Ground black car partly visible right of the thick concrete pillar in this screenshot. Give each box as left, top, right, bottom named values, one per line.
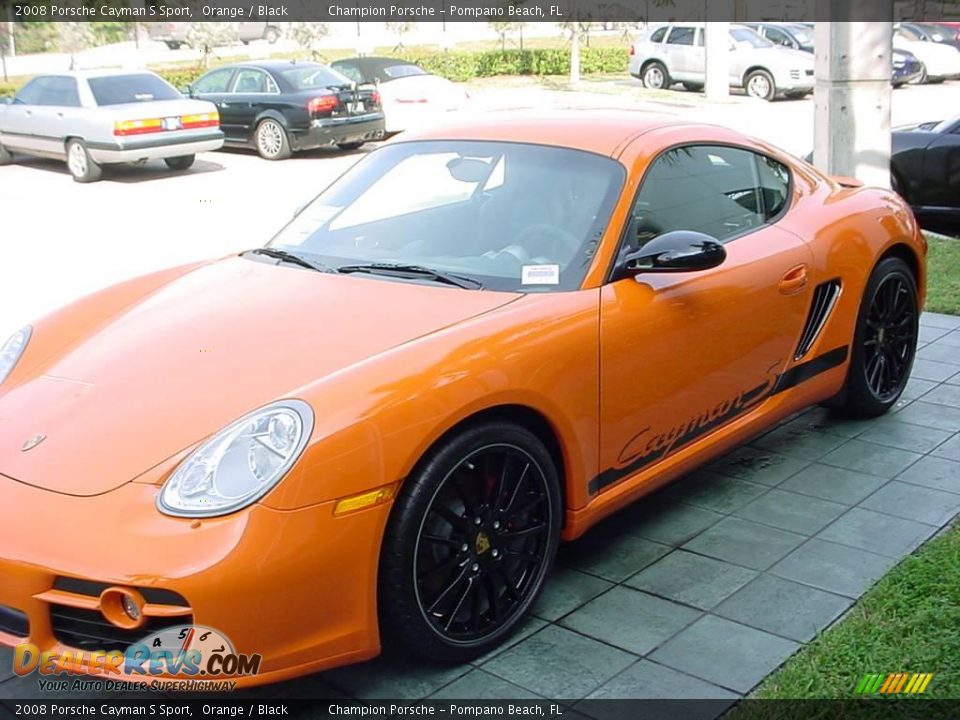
left=891, top=116, right=960, bottom=227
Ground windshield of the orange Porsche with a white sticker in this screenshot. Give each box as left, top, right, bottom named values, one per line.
left=270, top=140, right=626, bottom=292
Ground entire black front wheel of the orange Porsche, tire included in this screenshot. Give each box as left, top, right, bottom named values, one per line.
left=378, top=421, right=562, bottom=662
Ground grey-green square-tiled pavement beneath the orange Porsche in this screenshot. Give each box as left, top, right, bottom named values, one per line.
left=0, top=313, right=960, bottom=704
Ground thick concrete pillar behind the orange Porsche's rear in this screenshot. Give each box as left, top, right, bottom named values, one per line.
left=813, top=17, right=893, bottom=187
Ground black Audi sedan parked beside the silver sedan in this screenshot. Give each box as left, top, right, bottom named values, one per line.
left=185, top=60, right=384, bottom=160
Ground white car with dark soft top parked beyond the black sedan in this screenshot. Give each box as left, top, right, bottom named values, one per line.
left=330, top=57, right=470, bottom=133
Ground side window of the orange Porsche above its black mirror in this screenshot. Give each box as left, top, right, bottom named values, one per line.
left=628, top=145, right=790, bottom=248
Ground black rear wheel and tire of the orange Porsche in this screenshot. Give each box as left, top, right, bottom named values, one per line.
left=833, top=257, right=920, bottom=418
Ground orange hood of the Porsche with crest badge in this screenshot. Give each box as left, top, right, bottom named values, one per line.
left=0, top=257, right=520, bottom=495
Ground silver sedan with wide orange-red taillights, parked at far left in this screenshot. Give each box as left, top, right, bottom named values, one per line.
left=0, top=70, right=223, bottom=182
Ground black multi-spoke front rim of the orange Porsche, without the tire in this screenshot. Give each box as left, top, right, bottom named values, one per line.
left=414, top=445, right=555, bottom=641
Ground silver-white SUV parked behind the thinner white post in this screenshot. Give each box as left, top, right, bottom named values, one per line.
left=630, top=23, right=814, bottom=100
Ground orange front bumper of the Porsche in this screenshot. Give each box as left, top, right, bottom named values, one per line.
left=0, top=476, right=390, bottom=686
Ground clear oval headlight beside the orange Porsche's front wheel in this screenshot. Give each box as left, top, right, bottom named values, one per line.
left=157, top=400, right=313, bottom=517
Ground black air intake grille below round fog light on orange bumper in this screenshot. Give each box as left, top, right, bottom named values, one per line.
left=50, top=605, right=193, bottom=652
